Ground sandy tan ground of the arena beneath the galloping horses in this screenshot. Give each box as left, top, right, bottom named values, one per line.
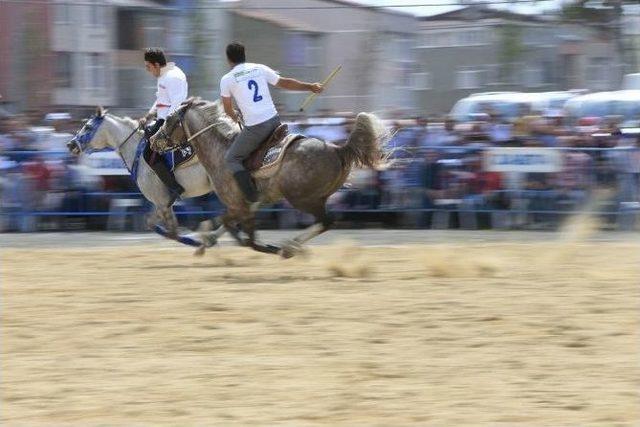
left=0, top=232, right=640, bottom=426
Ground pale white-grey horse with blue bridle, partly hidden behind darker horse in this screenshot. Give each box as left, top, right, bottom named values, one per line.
left=67, top=107, right=218, bottom=251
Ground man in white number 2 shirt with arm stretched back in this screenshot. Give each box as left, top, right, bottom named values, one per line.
left=220, top=42, right=323, bottom=208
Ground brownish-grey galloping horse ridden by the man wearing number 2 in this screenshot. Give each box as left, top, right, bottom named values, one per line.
left=151, top=98, right=389, bottom=257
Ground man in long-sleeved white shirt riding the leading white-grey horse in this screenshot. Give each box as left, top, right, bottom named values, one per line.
left=140, top=48, right=189, bottom=204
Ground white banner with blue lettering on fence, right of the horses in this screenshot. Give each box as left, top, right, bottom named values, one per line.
left=484, top=148, right=562, bottom=172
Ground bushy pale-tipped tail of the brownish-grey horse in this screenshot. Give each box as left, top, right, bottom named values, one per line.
left=338, top=113, right=391, bottom=168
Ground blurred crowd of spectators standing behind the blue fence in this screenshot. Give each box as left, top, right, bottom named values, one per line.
left=0, top=108, right=640, bottom=231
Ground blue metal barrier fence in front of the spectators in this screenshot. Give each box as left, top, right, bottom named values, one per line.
left=0, top=146, right=640, bottom=231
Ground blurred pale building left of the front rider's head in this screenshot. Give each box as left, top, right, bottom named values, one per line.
left=50, top=0, right=166, bottom=108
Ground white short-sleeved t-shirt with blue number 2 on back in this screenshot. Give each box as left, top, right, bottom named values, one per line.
left=220, top=62, right=280, bottom=126
